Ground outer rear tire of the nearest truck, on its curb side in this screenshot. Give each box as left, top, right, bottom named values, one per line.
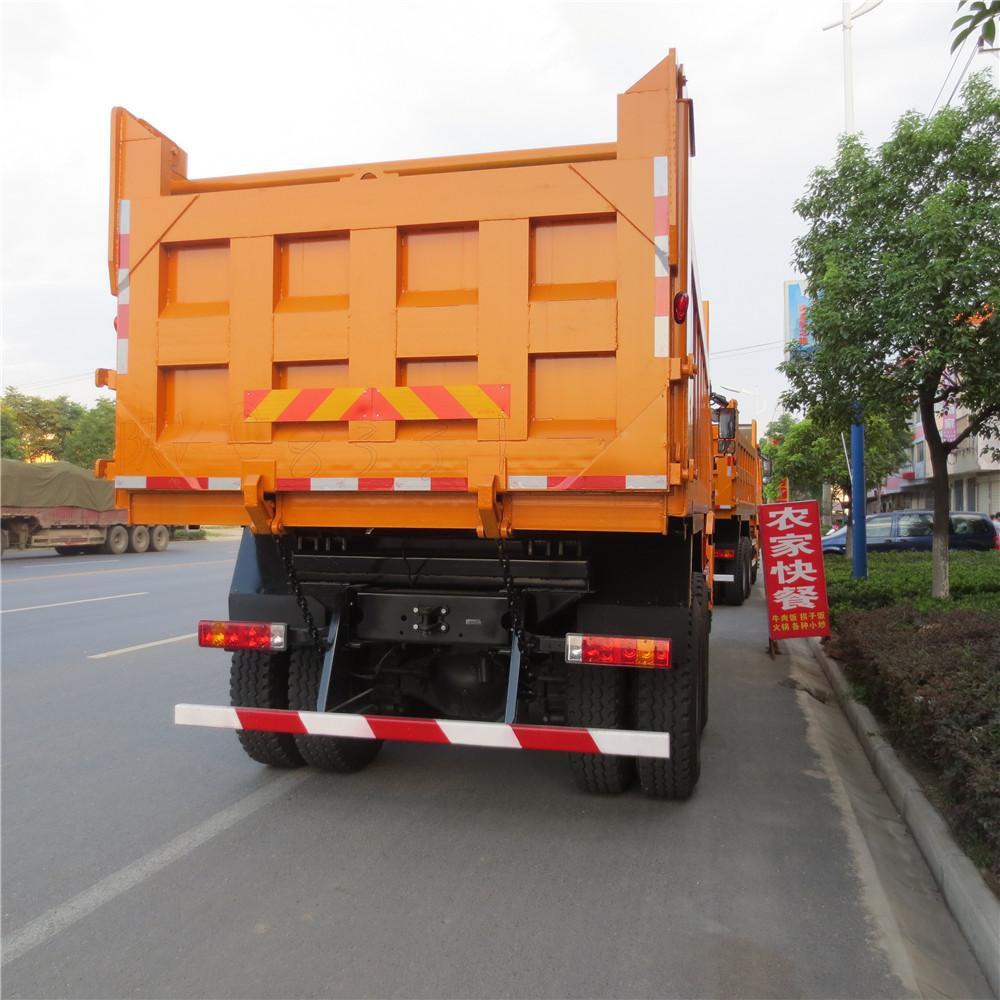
left=632, top=573, right=708, bottom=799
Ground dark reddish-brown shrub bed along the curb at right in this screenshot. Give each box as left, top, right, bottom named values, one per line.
left=830, top=596, right=1000, bottom=885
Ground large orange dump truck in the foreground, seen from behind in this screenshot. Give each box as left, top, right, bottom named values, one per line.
left=98, top=52, right=712, bottom=798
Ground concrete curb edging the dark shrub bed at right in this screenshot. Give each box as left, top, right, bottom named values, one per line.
left=807, top=639, right=1000, bottom=997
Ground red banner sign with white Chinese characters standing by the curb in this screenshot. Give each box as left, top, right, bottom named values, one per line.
left=759, top=500, right=830, bottom=639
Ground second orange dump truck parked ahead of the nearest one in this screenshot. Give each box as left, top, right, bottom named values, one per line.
left=712, top=395, right=764, bottom=605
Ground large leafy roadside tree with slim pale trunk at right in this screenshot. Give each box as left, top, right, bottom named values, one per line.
left=781, top=74, right=1000, bottom=597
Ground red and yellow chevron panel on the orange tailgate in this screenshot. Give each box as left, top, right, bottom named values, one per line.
left=243, top=385, right=510, bottom=424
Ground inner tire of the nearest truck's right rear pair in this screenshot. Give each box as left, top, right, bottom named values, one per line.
left=566, top=663, right=635, bottom=795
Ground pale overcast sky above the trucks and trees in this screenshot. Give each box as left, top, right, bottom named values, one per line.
left=2, top=0, right=990, bottom=423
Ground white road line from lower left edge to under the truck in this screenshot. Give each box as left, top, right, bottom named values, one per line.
left=2, top=771, right=312, bottom=965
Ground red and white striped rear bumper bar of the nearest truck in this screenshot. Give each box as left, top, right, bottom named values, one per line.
left=174, top=705, right=670, bottom=758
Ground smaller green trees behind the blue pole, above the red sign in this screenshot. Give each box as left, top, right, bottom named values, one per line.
left=765, top=414, right=911, bottom=499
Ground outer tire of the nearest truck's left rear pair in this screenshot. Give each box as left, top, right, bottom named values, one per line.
left=229, top=649, right=303, bottom=767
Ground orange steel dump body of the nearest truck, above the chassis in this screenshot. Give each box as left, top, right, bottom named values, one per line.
left=98, top=51, right=713, bottom=534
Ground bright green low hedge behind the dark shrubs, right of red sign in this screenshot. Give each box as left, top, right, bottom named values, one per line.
left=825, top=552, right=1000, bottom=616
